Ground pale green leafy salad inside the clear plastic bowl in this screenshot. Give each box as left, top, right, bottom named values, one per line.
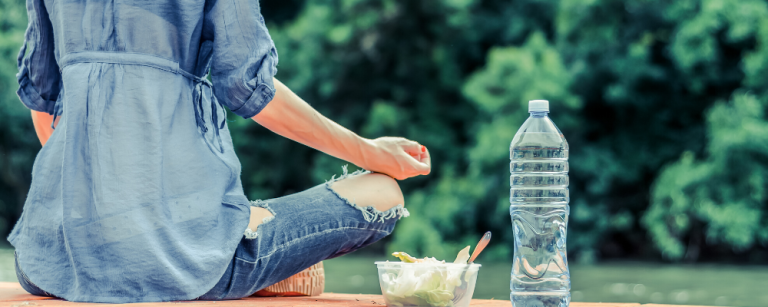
left=380, top=246, right=477, bottom=306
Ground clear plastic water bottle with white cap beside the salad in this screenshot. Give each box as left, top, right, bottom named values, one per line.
left=509, top=100, right=571, bottom=307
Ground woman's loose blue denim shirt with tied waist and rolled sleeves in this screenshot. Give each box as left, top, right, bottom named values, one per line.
left=8, top=0, right=277, bottom=303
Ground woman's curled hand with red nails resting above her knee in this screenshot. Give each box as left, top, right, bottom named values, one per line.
left=358, top=137, right=432, bottom=180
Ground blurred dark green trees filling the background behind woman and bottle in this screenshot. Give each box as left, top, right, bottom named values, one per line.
left=0, top=0, right=768, bottom=263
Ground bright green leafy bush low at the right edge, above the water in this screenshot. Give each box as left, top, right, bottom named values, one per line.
left=643, top=94, right=768, bottom=260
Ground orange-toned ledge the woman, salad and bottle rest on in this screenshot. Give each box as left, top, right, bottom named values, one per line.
left=0, top=282, right=716, bottom=307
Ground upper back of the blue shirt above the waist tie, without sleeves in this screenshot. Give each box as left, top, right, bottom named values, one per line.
left=50, top=0, right=208, bottom=74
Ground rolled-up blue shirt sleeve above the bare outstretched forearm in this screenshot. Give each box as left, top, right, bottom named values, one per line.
left=204, top=0, right=278, bottom=118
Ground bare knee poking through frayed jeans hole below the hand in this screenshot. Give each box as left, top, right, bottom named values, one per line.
left=331, top=173, right=405, bottom=211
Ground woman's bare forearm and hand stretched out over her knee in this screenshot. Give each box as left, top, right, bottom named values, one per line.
left=253, top=79, right=431, bottom=180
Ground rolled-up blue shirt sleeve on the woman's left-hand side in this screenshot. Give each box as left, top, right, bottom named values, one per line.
left=16, top=0, right=61, bottom=114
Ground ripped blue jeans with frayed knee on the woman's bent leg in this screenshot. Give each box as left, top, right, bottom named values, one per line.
left=198, top=168, right=408, bottom=300
